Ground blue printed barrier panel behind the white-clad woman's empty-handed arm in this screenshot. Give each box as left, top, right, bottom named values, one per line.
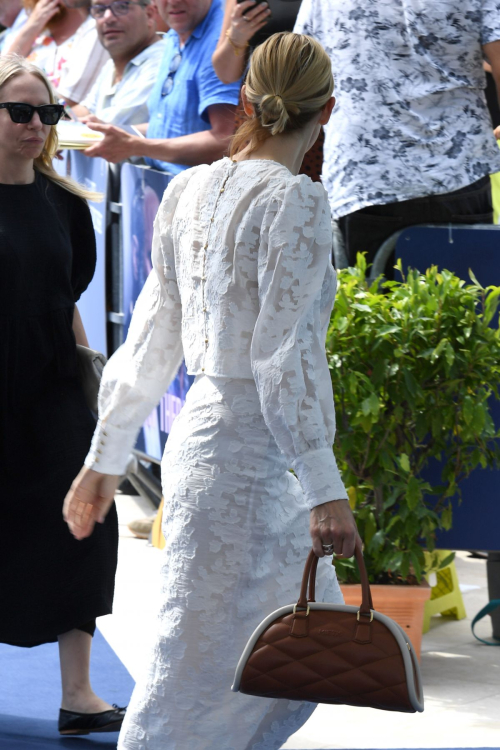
left=120, top=164, right=194, bottom=459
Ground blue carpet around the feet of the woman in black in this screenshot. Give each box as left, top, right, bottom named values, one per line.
left=0, top=630, right=134, bottom=750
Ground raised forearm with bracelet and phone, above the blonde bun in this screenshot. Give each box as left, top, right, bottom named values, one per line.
left=212, top=0, right=271, bottom=83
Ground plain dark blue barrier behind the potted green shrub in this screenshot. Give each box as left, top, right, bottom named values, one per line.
left=396, top=225, right=500, bottom=550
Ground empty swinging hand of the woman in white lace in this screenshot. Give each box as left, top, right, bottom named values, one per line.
left=63, top=466, right=120, bottom=539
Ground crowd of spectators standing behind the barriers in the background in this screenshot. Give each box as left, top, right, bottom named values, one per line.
left=0, top=0, right=500, bottom=214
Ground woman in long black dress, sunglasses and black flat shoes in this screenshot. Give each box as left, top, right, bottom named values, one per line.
left=0, top=56, right=123, bottom=734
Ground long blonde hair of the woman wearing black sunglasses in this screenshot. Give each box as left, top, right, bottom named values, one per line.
left=0, top=55, right=102, bottom=201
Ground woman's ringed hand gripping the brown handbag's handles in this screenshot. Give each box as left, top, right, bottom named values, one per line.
left=309, top=500, right=359, bottom=557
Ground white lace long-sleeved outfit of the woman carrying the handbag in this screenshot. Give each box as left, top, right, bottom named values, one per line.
left=86, top=159, right=346, bottom=750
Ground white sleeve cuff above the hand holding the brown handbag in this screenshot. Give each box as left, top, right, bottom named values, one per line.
left=292, top=448, right=347, bottom=510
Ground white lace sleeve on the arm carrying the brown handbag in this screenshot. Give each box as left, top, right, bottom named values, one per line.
left=251, top=177, right=347, bottom=508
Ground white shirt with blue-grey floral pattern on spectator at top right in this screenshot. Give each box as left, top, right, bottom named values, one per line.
left=295, top=0, right=500, bottom=218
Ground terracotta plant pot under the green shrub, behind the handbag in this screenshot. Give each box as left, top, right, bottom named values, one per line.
left=340, top=581, right=431, bottom=660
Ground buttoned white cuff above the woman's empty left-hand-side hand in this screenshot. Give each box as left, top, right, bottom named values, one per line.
left=85, top=421, right=139, bottom=476
